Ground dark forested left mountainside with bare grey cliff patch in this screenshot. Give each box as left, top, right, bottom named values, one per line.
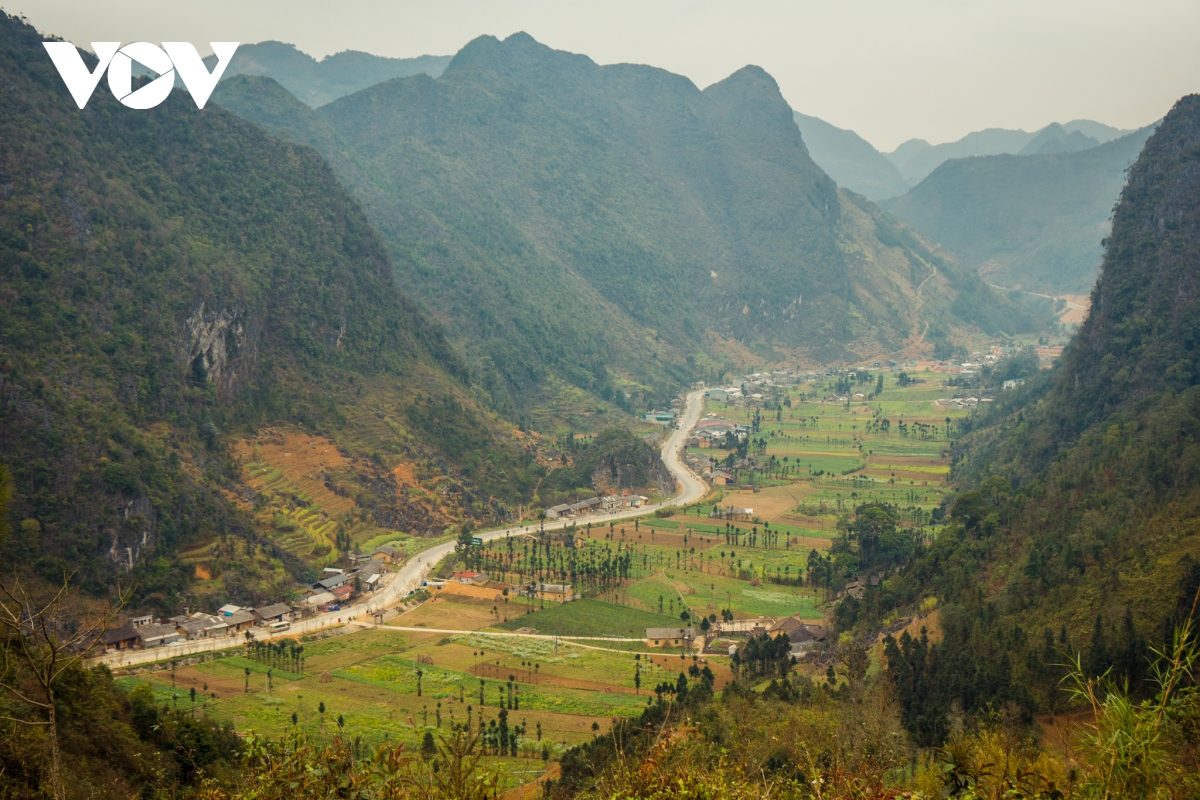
left=0, top=16, right=535, bottom=608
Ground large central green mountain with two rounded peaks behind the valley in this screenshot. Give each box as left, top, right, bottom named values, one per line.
left=216, top=34, right=1036, bottom=417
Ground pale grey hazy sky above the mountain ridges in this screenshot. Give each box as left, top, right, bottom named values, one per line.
left=11, top=0, right=1200, bottom=150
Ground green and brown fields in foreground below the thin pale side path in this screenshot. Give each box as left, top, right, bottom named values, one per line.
left=120, top=627, right=690, bottom=786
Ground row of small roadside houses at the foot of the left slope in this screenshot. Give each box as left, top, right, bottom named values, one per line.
left=96, top=545, right=404, bottom=652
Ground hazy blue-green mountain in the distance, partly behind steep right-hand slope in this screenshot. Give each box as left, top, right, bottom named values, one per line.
left=883, top=126, right=1153, bottom=294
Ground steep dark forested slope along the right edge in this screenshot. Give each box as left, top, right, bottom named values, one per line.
left=866, top=95, right=1200, bottom=742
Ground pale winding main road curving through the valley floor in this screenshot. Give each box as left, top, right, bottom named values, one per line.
left=103, top=390, right=708, bottom=668
